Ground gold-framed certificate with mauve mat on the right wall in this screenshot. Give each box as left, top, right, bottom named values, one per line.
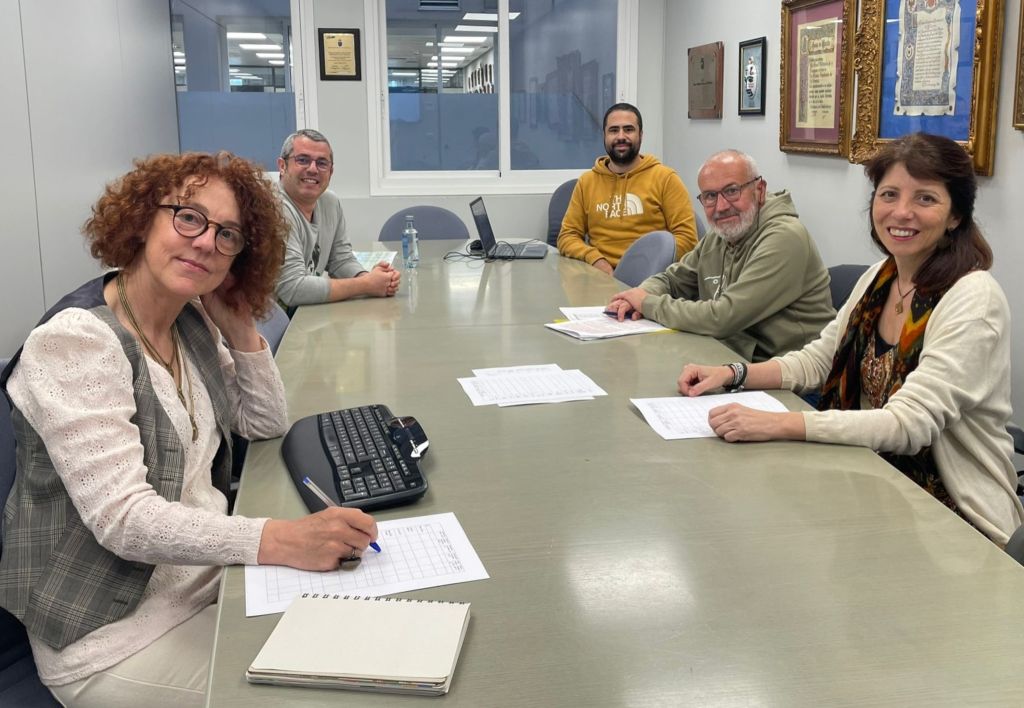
left=778, top=0, right=856, bottom=157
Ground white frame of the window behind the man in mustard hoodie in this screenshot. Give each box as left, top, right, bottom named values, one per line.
left=358, top=0, right=639, bottom=197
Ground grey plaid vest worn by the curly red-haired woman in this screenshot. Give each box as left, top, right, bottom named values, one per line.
left=0, top=274, right=231, bottom=649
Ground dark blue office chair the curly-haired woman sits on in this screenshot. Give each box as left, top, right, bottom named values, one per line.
left=0, top=359, right=59, bottom=708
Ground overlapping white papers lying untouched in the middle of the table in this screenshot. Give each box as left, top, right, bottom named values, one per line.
left=459, top=369, right=607, bottom=406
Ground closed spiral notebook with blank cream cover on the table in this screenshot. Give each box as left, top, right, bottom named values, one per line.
left=246, top=593, right=469, bottom=696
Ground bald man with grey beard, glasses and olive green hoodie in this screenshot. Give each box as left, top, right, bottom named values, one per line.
left=608, top=150, right=836, bottom=362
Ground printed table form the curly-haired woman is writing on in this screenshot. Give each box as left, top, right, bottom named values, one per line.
left=246, top=512, right=490, bottom=617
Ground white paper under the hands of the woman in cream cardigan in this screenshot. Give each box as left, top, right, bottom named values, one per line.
left=630, top=390, right=788, bottom=440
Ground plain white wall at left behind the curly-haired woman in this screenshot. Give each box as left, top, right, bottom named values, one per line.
left=0, top=0, right=178, bottom=357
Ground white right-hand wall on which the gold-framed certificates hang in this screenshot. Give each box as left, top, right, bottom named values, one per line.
left=659, top=0, right=1024, bottom=418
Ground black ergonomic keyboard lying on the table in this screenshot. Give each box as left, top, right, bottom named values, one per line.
left=281, top=404, right=429, bottom=511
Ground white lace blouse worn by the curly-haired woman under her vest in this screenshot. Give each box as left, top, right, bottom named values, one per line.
left=8, top=308, right=288, bottom=685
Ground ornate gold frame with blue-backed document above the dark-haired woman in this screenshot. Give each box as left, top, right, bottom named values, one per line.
left=850, top=0, right=1003, bottom=175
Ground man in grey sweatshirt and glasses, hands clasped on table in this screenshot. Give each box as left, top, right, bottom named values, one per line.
left=276, top=128, right=400, bottom=314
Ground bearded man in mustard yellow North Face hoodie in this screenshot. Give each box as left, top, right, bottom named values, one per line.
left=558, top=103, right=697, bottom=276
